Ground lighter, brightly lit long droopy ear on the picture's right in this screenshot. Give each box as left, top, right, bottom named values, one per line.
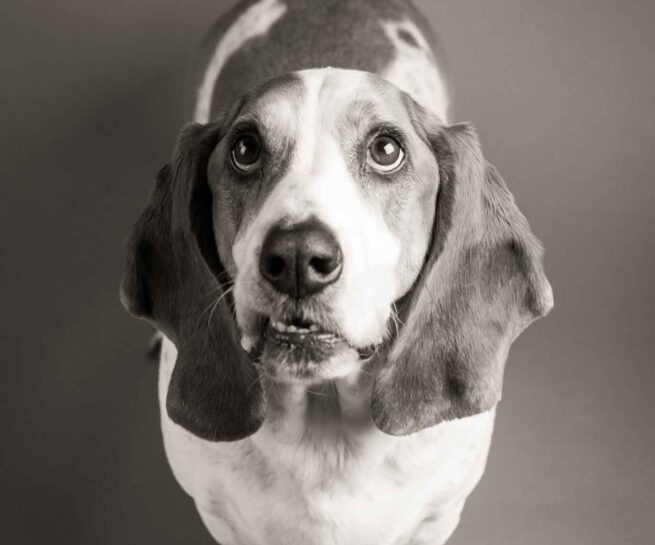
left=372, top=125, right=553, bottom=435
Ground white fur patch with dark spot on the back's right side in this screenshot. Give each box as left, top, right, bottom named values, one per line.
left=382, top=19, right=448, bottom=123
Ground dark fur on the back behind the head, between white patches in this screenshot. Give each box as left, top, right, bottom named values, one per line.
left=203, top=0, right=442, bottom=118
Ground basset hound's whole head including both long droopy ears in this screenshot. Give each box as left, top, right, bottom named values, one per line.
left=122, top=69, right=552, bottom=440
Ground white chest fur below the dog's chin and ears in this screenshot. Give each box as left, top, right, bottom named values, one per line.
left=159, top=338, right=494, bottom=545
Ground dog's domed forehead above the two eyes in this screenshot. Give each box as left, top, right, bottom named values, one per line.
left=237, top=68, right=412, bottom=134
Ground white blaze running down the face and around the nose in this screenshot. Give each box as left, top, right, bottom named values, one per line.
left=232, top=69, right=402, bottom=347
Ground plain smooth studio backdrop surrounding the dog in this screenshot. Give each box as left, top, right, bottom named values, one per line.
left=0, top=0, right=655, bottom=545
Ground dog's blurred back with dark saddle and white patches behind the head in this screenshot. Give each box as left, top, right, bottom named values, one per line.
left=194, top=0, right=448, bottom=123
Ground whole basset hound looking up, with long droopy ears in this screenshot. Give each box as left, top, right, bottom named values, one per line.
left=121, top=0, right=553, bottom=545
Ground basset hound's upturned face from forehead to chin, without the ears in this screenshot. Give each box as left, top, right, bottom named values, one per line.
left=208, top=70, right=439, bottom=381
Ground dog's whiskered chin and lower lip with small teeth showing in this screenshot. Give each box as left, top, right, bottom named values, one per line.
left=244, top=318, right=372, bottom=384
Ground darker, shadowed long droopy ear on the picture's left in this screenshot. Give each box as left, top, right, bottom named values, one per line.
left=121, top=123, right=265, bottom=441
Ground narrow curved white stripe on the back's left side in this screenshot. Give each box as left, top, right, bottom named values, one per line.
left=193, top=0, right=287, bottom=123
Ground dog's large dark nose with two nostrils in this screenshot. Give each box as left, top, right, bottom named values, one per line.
left=259, top=220, right=343, bottom=299
